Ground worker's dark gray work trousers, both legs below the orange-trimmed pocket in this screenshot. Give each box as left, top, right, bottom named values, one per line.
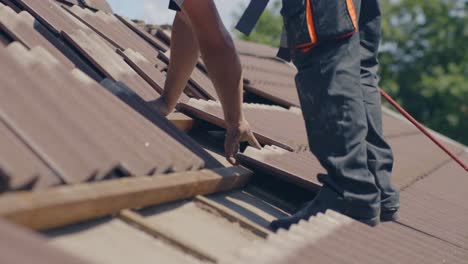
left=283, top=0, right=399, bottom=218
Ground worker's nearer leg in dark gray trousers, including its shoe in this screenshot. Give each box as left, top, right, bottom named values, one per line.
left=272, top=1, right=380, bottom=228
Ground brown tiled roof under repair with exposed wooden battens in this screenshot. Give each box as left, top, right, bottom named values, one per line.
left=0, top=0, right=468, bottom=264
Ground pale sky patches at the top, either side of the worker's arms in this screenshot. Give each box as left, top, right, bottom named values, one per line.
left=107, top=0, right=249, bottom=28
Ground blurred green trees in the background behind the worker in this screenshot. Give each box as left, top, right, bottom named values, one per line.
left=237, top=0, right=468, bottom=144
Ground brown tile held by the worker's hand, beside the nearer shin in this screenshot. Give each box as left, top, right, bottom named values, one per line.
left=237, top=146, right=325, bottom=192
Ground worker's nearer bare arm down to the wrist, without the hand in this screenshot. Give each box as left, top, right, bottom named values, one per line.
left=183, top=0, right=245, bottom=126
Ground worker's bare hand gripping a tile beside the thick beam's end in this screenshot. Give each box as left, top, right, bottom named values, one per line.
left=224, top=121, right=261, bottom=165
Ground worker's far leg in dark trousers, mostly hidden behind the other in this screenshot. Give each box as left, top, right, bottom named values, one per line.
left=359, top=0, right=399, bottom=220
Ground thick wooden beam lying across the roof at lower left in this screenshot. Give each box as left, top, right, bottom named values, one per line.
left=0, top=167, right=252, bottom=230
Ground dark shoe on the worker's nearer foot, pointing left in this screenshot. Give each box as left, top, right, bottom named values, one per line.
left=270, top=187, right=380, bottom=230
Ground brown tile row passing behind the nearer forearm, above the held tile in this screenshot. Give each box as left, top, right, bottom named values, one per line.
left=179, top=99, right=308, bottom=151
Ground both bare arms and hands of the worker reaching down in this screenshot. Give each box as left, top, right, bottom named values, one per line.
left=153, top=0, right=260, bottom=163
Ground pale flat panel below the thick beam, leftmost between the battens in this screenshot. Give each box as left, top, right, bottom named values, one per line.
left=46, top=218, right=201, bottom=264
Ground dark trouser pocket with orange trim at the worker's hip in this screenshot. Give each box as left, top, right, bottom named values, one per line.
left=281, top=0, right=358, bottom=50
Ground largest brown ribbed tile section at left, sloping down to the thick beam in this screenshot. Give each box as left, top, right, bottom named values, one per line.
left=0, top=43, right=204, bottom=192
